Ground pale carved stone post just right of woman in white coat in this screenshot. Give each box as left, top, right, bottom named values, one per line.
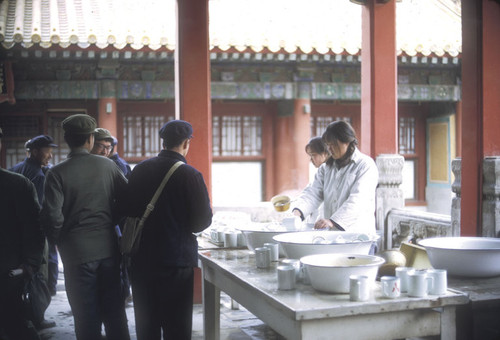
left=376, top=154, right=405, bottom=250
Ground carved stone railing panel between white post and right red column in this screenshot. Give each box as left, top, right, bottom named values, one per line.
left=384, top=209, right=460, bottom=249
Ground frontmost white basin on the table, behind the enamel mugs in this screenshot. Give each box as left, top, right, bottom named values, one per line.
left=300, top=254, right=385, bottom=293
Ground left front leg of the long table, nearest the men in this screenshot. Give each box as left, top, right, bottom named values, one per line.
left=203, top=279, right=220, bottom=340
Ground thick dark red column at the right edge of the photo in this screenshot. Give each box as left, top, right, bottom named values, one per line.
left=460, top=0, right=500, bottom=236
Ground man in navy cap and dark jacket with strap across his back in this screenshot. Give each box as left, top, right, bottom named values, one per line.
left=120, top=120, right=212, bottom=340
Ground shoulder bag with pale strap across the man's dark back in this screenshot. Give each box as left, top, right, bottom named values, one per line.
left=120, top=161, right=183, bottom=256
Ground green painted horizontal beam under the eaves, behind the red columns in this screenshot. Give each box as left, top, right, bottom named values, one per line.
left=15, top=79, right=460, bottom=101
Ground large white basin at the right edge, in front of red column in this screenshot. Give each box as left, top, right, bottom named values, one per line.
left=418, top=237, right=500, bottom=277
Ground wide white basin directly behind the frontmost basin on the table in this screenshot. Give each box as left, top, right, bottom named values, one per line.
left=273, top=230, right=380, bottom=259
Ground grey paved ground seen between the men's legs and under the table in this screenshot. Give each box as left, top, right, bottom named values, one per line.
left=40, top=273, right=283, bottom=340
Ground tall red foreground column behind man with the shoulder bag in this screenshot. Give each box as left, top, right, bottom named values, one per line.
left=175, top=0, right=212, bottom=196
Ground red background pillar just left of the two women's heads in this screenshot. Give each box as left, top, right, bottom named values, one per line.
left=273, top=99, right=311, bottom=195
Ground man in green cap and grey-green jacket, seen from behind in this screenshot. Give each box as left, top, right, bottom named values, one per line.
left=40, top=114, right=130, bottom=340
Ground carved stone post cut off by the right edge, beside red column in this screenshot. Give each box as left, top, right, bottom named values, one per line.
left=482, top=156, right=500, bottom=237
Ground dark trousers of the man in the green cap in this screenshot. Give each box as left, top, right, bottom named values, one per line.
left=64, top=257, right=130, bottom=340
